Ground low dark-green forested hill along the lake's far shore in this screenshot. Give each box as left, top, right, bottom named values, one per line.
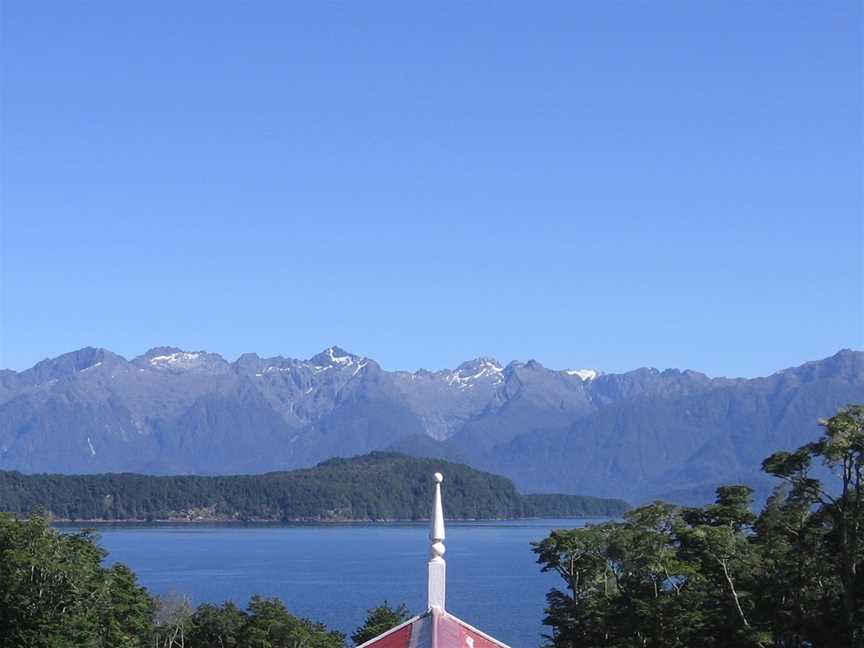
left=0, top=452, right=627, bottom=521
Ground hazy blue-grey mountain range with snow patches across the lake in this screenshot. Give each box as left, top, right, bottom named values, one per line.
left=0, top=346, right=864, bottom=503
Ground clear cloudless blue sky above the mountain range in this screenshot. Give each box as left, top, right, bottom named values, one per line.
left=0, top=0, right=864, bottom=376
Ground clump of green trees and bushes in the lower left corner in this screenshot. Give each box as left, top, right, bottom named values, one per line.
left=0, top=514, right=348, bottom=648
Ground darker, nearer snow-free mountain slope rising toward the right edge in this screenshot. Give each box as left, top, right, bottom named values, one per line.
left=475, top=352, right=864, bottom=502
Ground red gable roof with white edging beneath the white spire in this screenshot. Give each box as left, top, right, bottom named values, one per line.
left=360, top=608, right=509, bottom=648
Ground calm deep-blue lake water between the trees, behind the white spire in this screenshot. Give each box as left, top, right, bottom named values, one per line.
left=62, top=520, right=585, bottom=648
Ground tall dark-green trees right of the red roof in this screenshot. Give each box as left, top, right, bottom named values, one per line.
left=534, top=406, right=864, bottom=648
